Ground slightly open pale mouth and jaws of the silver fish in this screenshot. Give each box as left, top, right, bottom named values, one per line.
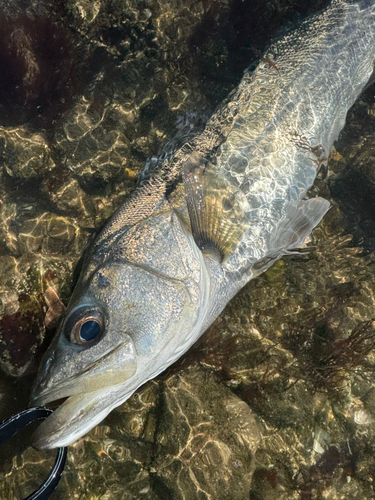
left=31, top=336, right=137, bottom=450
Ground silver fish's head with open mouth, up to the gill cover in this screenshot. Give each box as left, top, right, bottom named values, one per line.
left=32, top=212, right=210, bottom=449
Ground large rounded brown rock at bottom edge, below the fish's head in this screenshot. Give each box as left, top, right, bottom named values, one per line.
left=151, top=369, right=260, bottom=500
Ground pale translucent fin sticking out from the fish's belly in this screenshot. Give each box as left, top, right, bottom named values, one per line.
left=268, top=198, right=330, bottom=253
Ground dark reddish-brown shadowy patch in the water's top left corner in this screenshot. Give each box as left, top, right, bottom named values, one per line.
left=0, top=2, right=103, bottom=136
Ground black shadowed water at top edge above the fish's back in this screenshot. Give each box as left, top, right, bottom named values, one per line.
left=189, top=0, right=329, bottom=104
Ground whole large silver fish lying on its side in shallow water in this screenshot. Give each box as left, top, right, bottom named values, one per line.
left=32, top=0, right=375, bottom=449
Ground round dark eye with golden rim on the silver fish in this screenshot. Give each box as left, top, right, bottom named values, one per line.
left=64, top=307, right=104, bottom=345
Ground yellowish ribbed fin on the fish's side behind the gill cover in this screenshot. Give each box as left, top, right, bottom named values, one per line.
left=184, top=155, right=247, bottom=261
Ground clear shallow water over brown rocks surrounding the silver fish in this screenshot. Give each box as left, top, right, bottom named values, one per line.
left=0, top=0, right=375, bottom=500
